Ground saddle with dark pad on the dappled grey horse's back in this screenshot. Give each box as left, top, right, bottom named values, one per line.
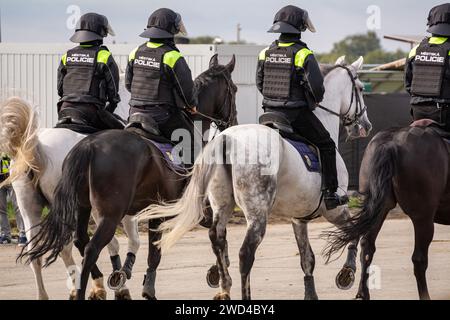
left=259, top=112, right=321, bottom=173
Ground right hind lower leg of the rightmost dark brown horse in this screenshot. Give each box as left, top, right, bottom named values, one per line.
left=412, top=215, right=434, bottom=300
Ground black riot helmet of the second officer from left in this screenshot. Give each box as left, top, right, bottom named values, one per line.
left=139, top=8, right=186, bottom=39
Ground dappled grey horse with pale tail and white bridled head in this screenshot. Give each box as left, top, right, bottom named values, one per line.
left=139, top=57, right=372, bottom=299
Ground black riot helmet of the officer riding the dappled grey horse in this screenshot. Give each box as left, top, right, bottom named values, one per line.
left=267, top=6, right=316, bottom=34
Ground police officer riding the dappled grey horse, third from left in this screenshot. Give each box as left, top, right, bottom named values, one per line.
left=256, top=6, right=345, bottom=210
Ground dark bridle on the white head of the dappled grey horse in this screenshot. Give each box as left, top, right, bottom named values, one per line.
left=317, top=65, right=367, bottom=127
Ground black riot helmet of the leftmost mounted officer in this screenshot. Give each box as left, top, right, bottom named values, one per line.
left=70, top=13, right=115, bottom=43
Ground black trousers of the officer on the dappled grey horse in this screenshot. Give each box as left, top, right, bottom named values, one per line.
left=265, top=107, right=338, bottom=192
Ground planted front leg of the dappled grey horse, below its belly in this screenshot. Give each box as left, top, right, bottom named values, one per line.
left=292, top=220, right=319, bottom=300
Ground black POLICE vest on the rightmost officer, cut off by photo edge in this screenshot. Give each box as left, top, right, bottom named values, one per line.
left=411, top=39, right=450, bottom=99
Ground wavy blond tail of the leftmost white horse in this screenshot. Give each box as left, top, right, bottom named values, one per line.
left=0, top=97, right=43, bottom=187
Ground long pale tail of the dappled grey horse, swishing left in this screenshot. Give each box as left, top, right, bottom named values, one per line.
left=138, top=135, right=225, bottom=251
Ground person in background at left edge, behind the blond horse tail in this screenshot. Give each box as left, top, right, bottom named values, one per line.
left=0, top=154, right=27, bottom=247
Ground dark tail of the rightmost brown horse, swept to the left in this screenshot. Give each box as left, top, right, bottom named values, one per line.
left=324, top=142, right=399, bottom=260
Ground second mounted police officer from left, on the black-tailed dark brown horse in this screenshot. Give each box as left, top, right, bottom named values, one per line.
left=125, top=8, right=197, bottom=151
